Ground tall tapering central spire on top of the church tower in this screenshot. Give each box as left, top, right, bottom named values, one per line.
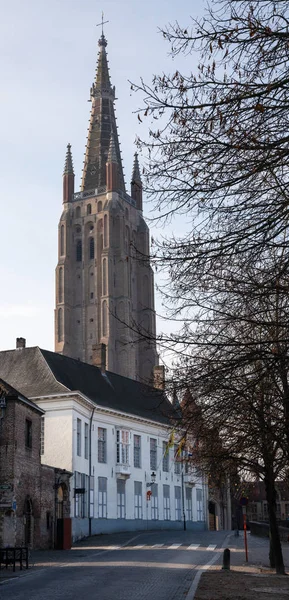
left=81, top=34, right=125, bottom=191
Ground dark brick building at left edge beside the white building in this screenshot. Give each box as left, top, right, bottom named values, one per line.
left=0, top=395, right=69, bottom=548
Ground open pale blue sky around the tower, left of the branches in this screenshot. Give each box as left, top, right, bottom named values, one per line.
left=0, top=0, right=204, bottom=350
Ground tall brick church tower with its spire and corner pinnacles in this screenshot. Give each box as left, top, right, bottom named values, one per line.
left=55, top=34, right=157, bottom=383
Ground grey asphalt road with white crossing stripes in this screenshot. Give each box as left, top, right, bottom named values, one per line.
left=0, top=531, right=241, bottom=600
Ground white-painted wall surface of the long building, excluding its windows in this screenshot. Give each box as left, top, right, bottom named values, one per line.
left=37, top=394, right=207, bottom=535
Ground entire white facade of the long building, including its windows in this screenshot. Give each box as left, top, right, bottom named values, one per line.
left=34, top=393, right=208, bottom=541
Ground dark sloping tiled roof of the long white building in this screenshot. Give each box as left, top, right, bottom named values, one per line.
left=0, top=347, right=173, bottom=424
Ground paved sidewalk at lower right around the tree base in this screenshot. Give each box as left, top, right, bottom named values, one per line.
left=194, top=532, right=289, bottom=600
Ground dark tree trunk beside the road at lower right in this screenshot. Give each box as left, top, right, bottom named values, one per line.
left=265, top=473, right=285, bottom=575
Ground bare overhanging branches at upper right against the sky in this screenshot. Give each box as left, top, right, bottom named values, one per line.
left=133, top=0, right=289, bottom=276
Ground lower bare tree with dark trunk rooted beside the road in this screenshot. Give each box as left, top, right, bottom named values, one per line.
left=166, top=250, right=289, bottom=573
